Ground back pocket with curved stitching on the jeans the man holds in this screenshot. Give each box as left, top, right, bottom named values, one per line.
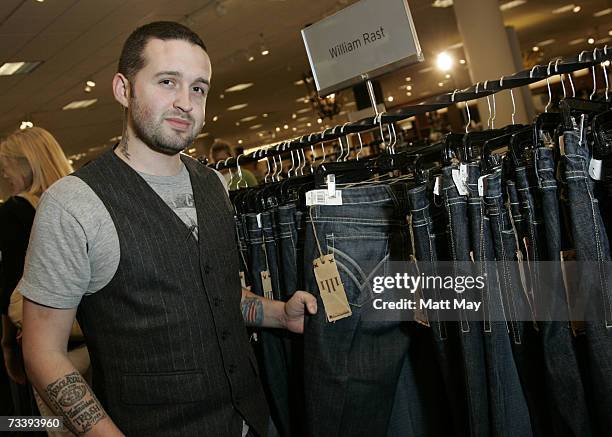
left=326, top=233, right=389, bottom=307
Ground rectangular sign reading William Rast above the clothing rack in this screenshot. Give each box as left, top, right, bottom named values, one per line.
left=302, top=0, right=424, bottom=96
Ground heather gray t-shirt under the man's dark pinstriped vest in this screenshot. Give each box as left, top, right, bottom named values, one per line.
left=17, top=165, right=227, bottom=308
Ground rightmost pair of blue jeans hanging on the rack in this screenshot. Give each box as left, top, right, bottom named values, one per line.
left=563, top=131, right=612, bottom=435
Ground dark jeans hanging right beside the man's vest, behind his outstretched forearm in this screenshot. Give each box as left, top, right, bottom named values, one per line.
left=245, top=212, right=291, bottom=437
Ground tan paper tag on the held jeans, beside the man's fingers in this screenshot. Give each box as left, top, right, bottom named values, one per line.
left=312, top=254, right=353, bottom=322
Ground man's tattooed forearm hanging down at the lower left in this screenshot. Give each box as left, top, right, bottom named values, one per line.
left=26, top=352, right=123, bottom=436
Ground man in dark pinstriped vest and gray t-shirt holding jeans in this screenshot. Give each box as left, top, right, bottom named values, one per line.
left=18, top=22, right=316, bottom=437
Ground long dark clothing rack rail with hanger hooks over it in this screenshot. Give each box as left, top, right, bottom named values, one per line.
left=210, top=45, right=612, bottom=170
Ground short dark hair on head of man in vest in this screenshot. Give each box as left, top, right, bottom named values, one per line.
left=117, top=21, right=207, bottom=80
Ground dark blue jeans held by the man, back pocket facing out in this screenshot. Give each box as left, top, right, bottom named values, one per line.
left=304, top=184, right=410, bottom=437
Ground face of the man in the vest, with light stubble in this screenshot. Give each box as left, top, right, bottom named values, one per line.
left=128, top=39, right=211, bottom=155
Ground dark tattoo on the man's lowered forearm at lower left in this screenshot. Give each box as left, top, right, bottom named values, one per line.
left=45, top=372, right=106, bottom=435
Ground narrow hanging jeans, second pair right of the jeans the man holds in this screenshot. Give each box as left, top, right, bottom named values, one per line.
left=442, top=166, right=490, bottom=437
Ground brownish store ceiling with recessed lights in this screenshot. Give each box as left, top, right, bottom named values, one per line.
left=0, top=0, right=612, bottom=162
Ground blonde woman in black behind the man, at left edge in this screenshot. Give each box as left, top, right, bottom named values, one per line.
left=0, top=127, right=89, bottom=435
